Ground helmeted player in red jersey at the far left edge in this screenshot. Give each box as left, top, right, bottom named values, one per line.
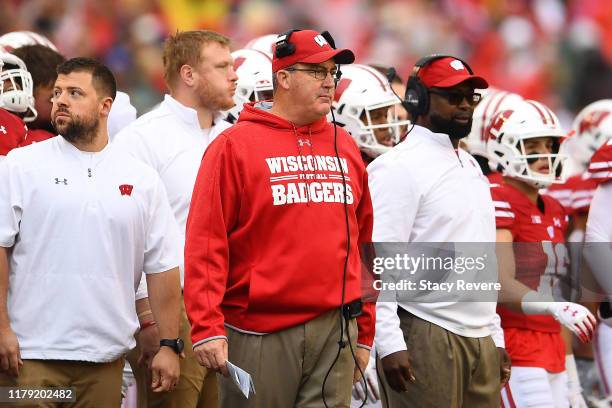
left=0, top=50, right=36, bottom=157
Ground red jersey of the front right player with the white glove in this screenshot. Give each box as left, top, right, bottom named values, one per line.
left=491, top=175, right=569, bottom=372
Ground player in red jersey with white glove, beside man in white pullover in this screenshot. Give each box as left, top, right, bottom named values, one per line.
left=487, top=100, right=595, bottom=407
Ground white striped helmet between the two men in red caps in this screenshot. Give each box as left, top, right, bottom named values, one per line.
left=328, top=64, right=410, bottom=158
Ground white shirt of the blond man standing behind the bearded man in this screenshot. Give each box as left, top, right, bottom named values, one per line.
left=113, top=95, right=231, bottom=286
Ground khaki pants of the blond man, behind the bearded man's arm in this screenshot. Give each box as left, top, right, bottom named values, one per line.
left=127, top=302, right=218, bottom=408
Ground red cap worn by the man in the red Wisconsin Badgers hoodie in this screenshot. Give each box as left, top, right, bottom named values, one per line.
left=272, top=30, right=355, bottom=72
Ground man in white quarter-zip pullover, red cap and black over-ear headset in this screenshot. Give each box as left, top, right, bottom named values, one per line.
left=368, top=56, right=509, bottom=407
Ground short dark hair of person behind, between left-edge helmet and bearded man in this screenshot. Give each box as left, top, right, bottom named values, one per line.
left=11, top=44, right=66, bottom=88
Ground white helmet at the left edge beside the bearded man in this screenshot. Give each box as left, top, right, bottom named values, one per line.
left=0, top=53, right=38, bottom=122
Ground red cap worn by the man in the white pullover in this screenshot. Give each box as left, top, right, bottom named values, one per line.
left=417, top=57, right=489, bottom=89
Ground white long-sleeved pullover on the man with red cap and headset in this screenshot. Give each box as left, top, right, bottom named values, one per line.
left=368, top=126, right=503, bottom=357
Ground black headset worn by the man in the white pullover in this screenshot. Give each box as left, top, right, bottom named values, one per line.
left=402, top=54, right=474, bottom=118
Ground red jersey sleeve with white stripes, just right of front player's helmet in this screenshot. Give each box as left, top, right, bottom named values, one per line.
left=544, top=173, right=597, bottom=215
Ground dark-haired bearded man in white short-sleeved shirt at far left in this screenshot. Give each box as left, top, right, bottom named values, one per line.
left=0, top=58, right=182, bottom=406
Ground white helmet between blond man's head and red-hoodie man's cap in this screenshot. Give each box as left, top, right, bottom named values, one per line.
left=225, top=49, right=272, bottom=123
